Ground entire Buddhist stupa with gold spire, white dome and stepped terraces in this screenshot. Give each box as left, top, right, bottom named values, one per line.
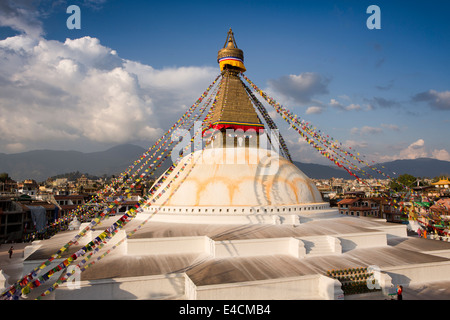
left=10, top=29, right=450, bottom=300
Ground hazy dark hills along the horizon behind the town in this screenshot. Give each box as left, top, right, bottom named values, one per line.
left=0, top=144, right=450, bottom=182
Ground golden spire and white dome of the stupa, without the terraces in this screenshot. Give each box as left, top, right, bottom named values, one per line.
left=149, top=29, right=328, bottom=224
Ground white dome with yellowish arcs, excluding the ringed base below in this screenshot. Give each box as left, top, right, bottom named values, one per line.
left=155, top=147, right=322, bottom=206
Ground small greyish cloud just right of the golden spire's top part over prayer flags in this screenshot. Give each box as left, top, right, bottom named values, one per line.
left=268, top=72, right=330, bottom=105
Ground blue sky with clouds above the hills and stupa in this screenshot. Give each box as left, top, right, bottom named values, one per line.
left=0, top=0, right=450, bottom=164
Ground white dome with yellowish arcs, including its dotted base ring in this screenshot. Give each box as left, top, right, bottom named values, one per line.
left=142, top=147, right=329, bottom=223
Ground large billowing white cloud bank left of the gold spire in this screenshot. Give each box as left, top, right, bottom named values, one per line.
left=0, top=34, right=217, bottom=152
